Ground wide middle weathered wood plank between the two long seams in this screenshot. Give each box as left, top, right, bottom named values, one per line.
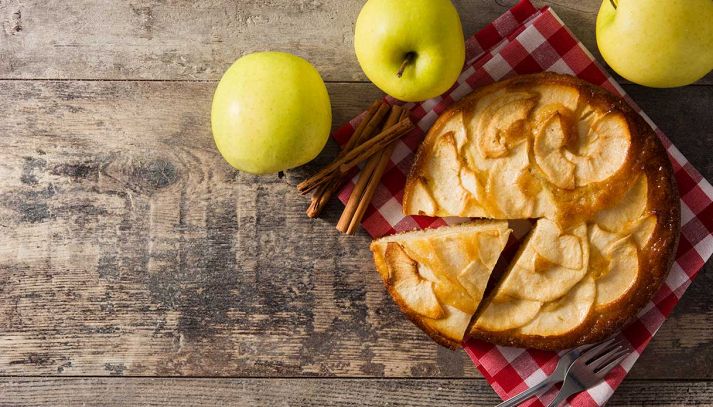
left=0, top=81, right=713, bottom=379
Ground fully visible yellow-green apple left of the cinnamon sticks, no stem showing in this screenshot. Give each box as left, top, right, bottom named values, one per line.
left=211, top=52, right=332, bottom=174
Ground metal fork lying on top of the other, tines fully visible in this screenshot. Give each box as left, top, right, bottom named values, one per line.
left=547, top=339, right=631, bottom=407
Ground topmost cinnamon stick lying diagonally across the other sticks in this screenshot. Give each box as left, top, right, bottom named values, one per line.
left=297, top=118, right=414, bottom=194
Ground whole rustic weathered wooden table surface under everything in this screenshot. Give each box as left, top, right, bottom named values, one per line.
left=0, top=0, right=713, bottom=406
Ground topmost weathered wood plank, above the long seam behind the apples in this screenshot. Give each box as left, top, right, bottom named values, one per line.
left=0, top=0, right=713, bottom=83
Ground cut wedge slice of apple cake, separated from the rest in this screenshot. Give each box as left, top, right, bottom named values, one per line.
left=371, top=221, right=510, bottom=348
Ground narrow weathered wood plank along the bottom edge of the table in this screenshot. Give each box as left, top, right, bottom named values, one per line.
left=0, top=377, right=713, bottom=407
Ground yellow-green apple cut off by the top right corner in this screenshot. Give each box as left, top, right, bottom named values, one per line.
left=596, top=0, right=713, bottom=88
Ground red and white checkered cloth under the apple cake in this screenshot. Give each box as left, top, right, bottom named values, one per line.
left=334, top=0, right=713, bottom=406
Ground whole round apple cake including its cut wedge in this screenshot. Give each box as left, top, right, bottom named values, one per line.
left=372, top=73, right=680, bottom=350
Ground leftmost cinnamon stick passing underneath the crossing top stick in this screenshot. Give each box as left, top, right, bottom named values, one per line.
left=307, top=100, right=389, bottom=218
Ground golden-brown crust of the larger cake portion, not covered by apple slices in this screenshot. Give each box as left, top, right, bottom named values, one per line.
left=403, top=73, right=680, bottom=350
